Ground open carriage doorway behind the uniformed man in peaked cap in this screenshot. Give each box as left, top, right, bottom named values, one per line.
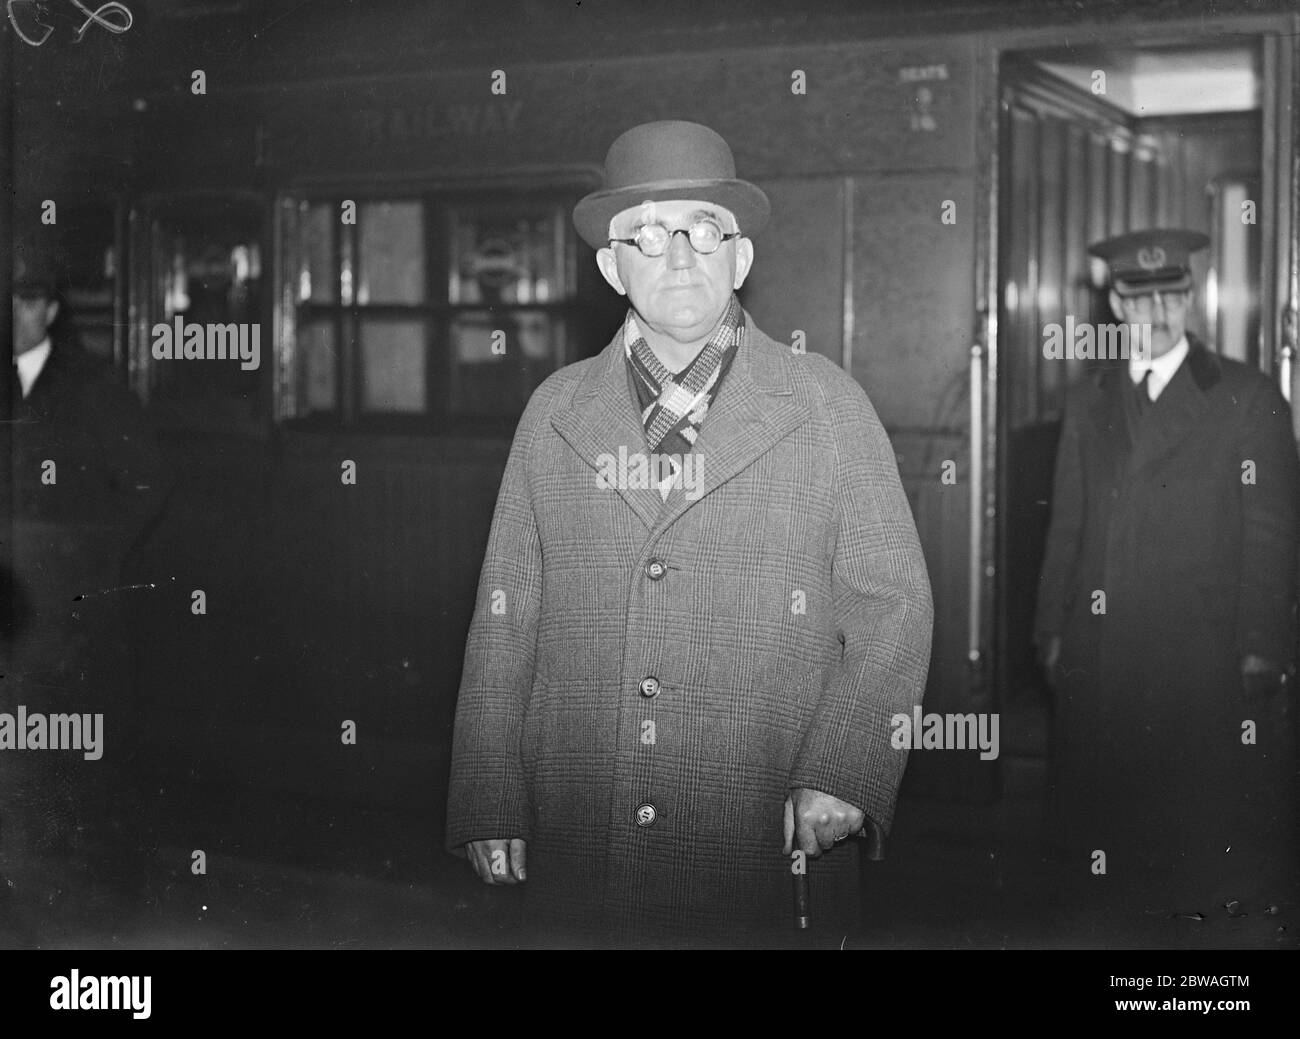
left=995, top=36, right=1277, bottom=756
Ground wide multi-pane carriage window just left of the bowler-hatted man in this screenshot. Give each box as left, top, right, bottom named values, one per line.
left=277, top=190, right=581, bottom=432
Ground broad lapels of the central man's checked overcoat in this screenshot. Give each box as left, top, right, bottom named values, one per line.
left=551, top=313, right=809, bottom=529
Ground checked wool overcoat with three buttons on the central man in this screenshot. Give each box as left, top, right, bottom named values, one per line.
left=446, top=315, right=932, bottom=940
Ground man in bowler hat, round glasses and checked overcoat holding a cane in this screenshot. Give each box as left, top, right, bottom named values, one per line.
left=447, top=122, right=932, bottom=944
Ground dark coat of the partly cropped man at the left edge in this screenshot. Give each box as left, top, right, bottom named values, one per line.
left=0, top=337, right=169, bottom=876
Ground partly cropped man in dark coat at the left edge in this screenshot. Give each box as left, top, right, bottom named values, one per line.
left=0, top=234, right=169, bottom=936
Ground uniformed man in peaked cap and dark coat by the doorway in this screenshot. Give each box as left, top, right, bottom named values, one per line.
left=1036, top=230, right=1300, bottom=919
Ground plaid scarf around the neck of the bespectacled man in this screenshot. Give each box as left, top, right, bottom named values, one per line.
left=623, top=295, right=745, bottom=456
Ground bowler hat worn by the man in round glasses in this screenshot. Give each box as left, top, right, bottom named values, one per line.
left=573, top=120, right=772, bottom=248
